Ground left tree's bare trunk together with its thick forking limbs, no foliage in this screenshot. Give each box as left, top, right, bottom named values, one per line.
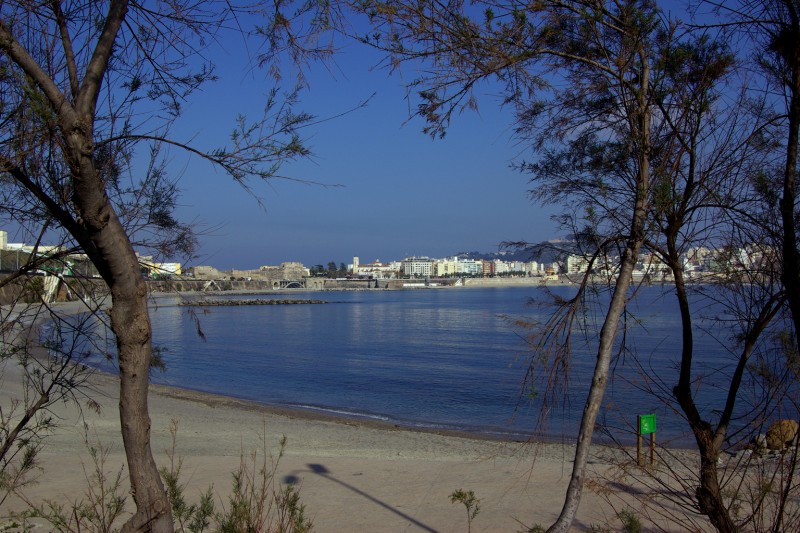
left=0, top=0, right=173, bottom=532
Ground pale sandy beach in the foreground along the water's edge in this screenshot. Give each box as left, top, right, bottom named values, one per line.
left=0, top=302, right=684, bottom=532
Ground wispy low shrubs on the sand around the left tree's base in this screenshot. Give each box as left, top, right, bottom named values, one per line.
left=11, top=420, right=313, bottom=533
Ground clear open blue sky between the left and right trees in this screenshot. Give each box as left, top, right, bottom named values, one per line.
left=171, top=27, right=557, bottom=268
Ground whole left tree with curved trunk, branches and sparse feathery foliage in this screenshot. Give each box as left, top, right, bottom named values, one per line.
left=0, top=0, right=310, bottom=531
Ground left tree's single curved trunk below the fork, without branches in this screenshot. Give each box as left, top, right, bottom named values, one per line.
left=66, top=130, right=173, bottom=532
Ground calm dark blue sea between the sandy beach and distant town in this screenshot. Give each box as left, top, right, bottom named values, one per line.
left=73, top=286, right=780, bottom=446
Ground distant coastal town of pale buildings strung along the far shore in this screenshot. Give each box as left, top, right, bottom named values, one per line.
left=0, top=230, right=770, bottom=288
